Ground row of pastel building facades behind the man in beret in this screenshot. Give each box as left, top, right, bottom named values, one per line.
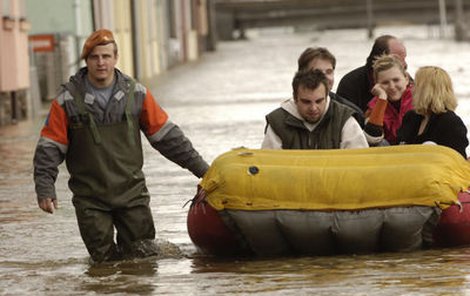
left=0, top=0, right=215, bottom=124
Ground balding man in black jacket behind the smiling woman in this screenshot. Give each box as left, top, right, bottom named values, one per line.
left=336, top=35, right=407, bottom=112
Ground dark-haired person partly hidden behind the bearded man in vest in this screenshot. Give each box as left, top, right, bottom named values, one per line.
left=297, top=47, right=364, bottom=127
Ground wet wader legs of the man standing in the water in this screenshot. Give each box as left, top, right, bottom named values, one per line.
left=73, top=194, right=158, bottom=262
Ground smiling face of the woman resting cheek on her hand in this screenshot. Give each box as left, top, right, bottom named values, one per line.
left=377, top=67, right=408, bottom=102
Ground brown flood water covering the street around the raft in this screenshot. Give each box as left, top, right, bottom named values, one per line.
left=0, top=27, right=470, bottom=295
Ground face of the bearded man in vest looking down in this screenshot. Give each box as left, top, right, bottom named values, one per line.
left=295, top=84, right=327, bottom=123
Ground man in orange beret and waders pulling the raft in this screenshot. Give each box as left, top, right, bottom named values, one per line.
left=34, top=29, right=208, bottom=262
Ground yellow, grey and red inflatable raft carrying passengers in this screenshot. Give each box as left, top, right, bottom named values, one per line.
left=187, top=145, right=470, bottom=256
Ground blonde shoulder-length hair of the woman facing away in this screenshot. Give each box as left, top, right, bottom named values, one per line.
left=413, top=66, right=457, bottom=115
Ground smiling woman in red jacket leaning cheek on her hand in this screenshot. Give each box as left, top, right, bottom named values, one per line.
left=364, top=55, right=413, bottom=146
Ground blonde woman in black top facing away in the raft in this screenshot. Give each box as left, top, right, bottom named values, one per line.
left=398, top=66, right=468, bottom=158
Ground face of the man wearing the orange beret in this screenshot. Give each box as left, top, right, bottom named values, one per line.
left=86, top=43, right=117, bottom=87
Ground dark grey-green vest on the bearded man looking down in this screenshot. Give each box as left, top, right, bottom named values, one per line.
left=266, top=100, right=354, bottom=149
